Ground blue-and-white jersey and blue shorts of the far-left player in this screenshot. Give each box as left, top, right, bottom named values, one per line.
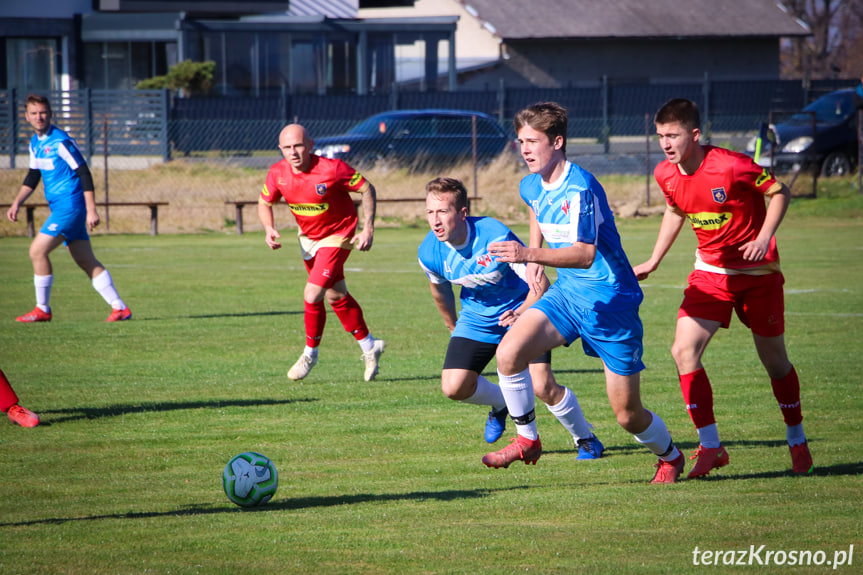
left=30, top=126, right=88, bottom=241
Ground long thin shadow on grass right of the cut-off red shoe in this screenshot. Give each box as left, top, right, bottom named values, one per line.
left=39, top=398, right=318, bottom=427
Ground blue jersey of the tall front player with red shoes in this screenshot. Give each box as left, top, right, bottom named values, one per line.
left=519, top=162, right=642, bottom=311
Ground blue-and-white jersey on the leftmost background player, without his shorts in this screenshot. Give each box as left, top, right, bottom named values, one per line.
left=30, top=126, right=86, bottom=213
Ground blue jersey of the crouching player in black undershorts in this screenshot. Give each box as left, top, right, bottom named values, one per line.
left=419, top=217, right=529, bottom=343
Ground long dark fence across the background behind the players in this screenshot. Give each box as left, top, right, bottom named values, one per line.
left=0, top=78, right=857, bottom=168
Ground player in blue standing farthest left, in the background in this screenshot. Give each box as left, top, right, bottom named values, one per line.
left=6, top=94, right=132, bottom=323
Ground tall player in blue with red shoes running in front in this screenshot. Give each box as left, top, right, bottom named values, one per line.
left=483, top=102, right=683, bottom=483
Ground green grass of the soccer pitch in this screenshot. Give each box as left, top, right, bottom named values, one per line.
left=0, top=197, right=863, bottom=575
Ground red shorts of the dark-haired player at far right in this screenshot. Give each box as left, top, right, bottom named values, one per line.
left=677, top=270, right=785, bottom=337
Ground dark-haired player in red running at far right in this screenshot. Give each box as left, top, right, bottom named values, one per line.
left=633, top=98, right=813, bottom=478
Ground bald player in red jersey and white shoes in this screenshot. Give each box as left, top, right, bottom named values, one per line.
left=258, top=124, right=385, bottom=381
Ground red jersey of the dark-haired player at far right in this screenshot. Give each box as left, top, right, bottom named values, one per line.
left=653, top=146, right=782, bottom=269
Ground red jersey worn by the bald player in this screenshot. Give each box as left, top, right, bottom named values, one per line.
left=260, top=155, right=369, bottom=240
